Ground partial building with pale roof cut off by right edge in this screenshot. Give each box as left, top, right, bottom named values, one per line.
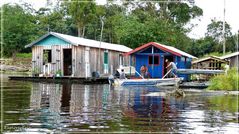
left=220, top=52, right=239, bottom=68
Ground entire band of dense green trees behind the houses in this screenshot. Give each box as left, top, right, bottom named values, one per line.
left=1, top=0, right=236, bottom=56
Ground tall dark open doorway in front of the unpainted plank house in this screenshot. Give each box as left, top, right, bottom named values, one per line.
left=63, top=49, right=72, bottom=76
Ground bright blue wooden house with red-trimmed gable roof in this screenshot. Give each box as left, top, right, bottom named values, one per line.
left=126, top=42, right=196, bottom=80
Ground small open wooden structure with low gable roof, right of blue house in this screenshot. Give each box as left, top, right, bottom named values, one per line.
left=192, top=56, right=228, bottom=70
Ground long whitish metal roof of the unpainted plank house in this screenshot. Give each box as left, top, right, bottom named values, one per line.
left=26, top=32, right=132, bottom=52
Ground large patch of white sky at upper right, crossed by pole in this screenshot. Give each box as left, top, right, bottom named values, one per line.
left=189, top=0, right=239, bottom=38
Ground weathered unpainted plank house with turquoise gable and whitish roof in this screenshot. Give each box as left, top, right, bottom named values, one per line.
left=26, top=32, right=132, bottom=77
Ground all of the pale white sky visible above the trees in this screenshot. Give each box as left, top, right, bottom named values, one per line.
left=0, top=0, right=239, bottom=39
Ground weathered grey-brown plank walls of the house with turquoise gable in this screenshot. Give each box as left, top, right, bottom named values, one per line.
left=32, top=45, right=129, bottom=77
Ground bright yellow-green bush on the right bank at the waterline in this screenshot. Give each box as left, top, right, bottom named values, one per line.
left=207, top=68, right=239, bottom=91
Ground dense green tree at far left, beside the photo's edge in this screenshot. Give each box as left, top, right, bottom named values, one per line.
left=1, top=4, right=36, bottom=57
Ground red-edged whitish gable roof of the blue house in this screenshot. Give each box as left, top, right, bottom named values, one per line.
left=127, top=42, right=197, bottom=59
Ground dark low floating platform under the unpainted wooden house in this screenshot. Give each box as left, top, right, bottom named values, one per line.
left=8, top=76, right=109, bottom=84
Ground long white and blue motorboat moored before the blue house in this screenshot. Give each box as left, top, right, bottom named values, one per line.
left=114, top=78, right=180, bottom=86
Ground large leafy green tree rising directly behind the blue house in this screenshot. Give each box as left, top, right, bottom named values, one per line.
left=112, top=1, right=202, bottom=51
